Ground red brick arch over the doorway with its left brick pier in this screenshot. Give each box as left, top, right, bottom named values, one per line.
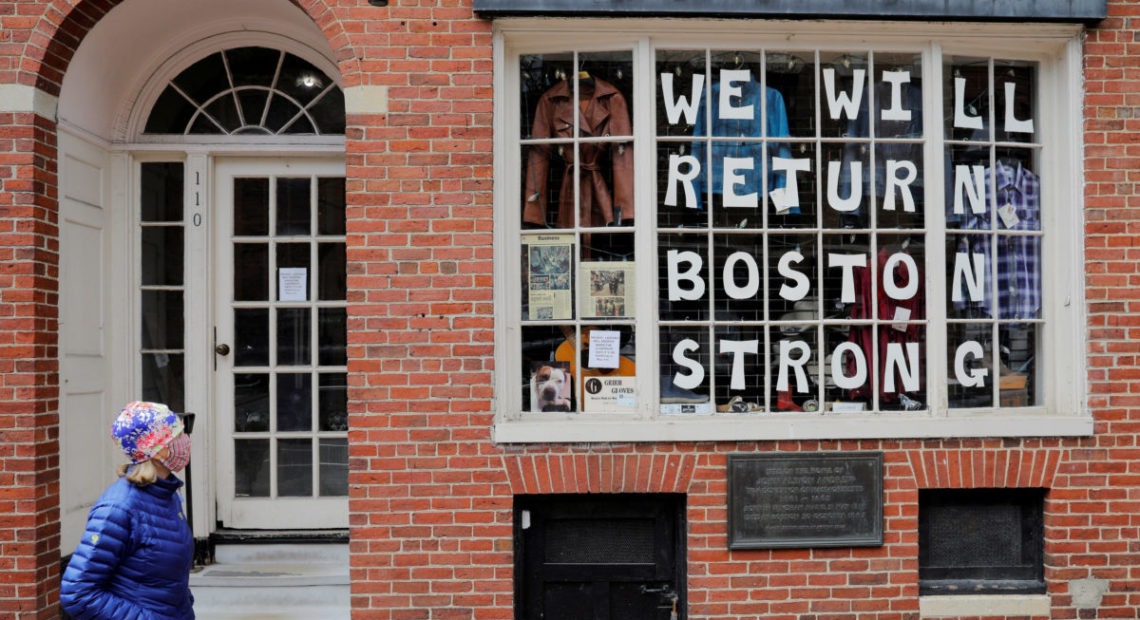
left=0, top=0, right=360, bottom=620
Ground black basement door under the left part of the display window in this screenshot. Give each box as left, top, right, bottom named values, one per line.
left=514, top=495, right=685, bottom=620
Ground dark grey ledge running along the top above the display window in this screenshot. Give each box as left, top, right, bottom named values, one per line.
left=474, top=0, right=1108, bottom=23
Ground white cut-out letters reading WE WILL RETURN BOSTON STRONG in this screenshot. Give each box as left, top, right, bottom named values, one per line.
left=660, top=68, right=1021, bottom=393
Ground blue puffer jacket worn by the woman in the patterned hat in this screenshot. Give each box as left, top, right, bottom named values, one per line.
left=59, top=476, right=194, bottom=620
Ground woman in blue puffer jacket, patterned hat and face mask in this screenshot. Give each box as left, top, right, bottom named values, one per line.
left=59, top=402, right=194, bottom=620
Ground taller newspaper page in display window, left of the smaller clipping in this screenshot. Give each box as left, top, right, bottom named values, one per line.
left=523, top=235, right=573, bottom=320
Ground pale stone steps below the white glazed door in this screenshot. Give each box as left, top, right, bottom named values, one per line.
left=190, top=544, right=351, bottom=620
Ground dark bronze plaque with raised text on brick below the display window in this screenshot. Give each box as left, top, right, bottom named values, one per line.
left=728, top=452, right=882, bottom=549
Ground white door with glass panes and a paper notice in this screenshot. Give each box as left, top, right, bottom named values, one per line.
left=213, top=157, right=348, bottom=529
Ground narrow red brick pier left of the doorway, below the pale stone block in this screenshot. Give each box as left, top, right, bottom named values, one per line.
left=0, top=105, right=59, bottom=619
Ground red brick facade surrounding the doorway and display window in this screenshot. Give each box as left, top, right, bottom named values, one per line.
left=0, top=0, right=1140, bottom=620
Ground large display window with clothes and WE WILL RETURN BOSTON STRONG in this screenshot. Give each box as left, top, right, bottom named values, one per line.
left=497, top=23, right=1080, bottom=437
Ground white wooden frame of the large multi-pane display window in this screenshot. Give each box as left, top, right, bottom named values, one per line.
left=494, top=18, right=1093, bottom=443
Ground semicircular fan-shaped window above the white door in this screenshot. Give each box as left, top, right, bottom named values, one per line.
left=145, top=47, right=344, bottom=136
